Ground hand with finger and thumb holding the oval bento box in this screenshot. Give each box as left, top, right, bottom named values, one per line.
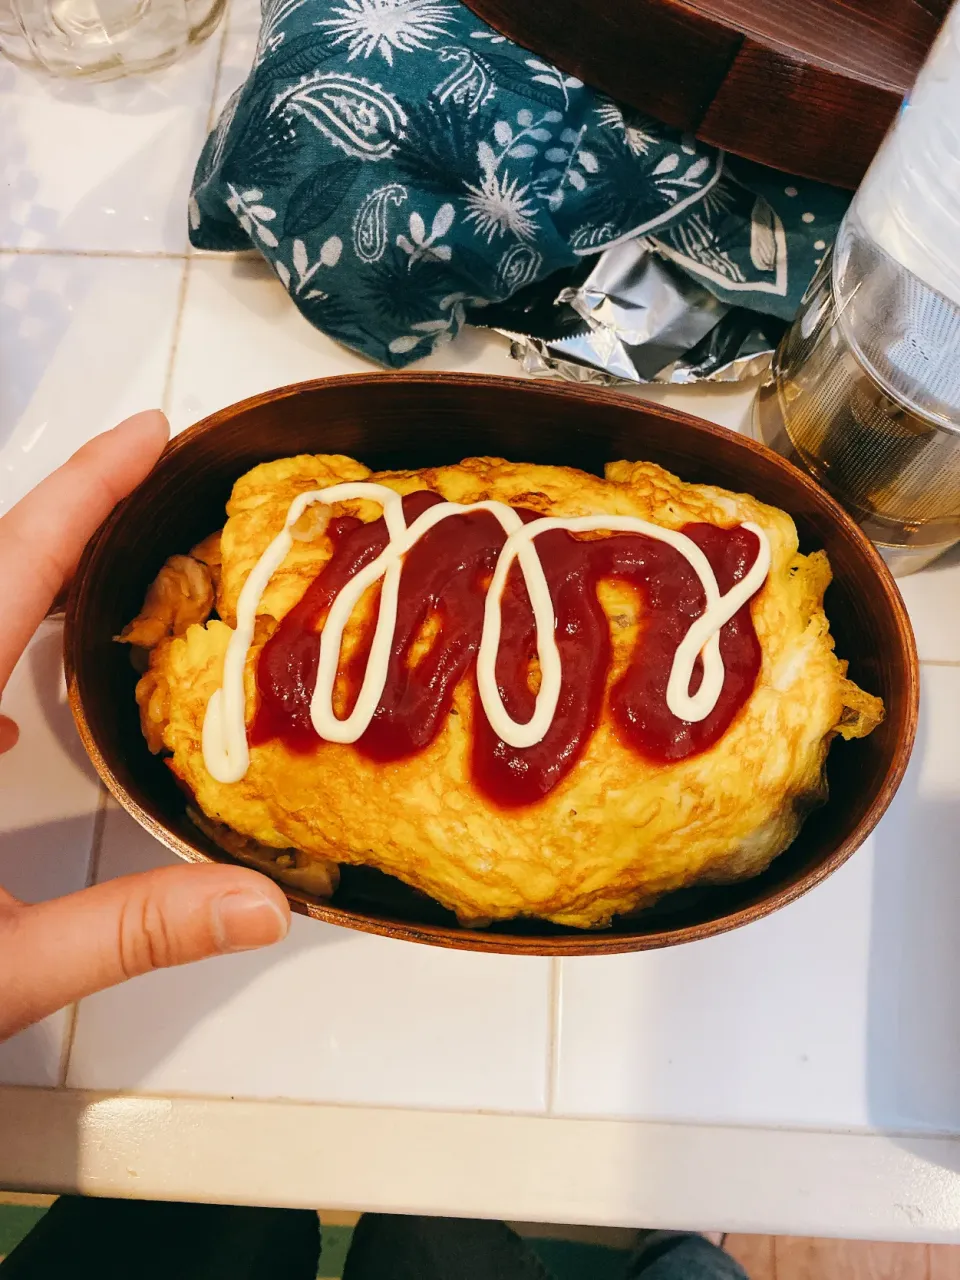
left=0, top=411, right=289, bottom=1041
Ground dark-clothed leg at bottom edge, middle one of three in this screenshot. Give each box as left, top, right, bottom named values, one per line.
left=343, top=1213, right=550, bottom=1280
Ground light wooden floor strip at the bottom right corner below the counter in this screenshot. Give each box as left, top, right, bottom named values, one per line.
left=724, top=1235, right=960, bottom=1280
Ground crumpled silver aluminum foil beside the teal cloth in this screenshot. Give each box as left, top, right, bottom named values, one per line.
left=470, top=239, right=786, bottom=387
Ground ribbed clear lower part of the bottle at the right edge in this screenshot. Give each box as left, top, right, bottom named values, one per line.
left=754, top=209, right=960, bottom=576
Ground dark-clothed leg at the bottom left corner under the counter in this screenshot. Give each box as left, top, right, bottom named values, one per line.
left=0, top=1196, right=320, bottom=1280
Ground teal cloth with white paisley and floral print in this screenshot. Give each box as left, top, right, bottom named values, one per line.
left=189, top=0, right=849, bottom=367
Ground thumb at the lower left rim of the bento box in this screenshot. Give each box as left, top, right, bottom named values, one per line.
left=0, top=865, right=291, bottom=1041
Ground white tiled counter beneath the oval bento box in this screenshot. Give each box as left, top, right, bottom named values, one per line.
left=0, top=6, right=960, bottom=1240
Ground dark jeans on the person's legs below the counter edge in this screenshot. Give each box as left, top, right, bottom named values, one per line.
left=0, top=1196, right=746, bottom=1280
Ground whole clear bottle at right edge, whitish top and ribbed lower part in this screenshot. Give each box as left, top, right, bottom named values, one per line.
left=755, top=5, right=960, bottom=573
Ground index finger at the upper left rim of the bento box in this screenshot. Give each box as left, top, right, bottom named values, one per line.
left=0, top=410, right=170, bottom=690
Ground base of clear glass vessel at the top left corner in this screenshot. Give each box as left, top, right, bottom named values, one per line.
left=0, top=0, right=225, bottom=79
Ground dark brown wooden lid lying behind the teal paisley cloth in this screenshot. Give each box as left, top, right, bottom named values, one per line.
left=466, top=0, right=950, bottom=188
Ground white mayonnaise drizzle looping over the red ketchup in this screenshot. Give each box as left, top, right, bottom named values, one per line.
left=202, top=483, right=771, bottom=782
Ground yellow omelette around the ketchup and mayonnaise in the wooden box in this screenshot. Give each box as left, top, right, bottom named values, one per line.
left=119, top=456, right=883, bottom=928
